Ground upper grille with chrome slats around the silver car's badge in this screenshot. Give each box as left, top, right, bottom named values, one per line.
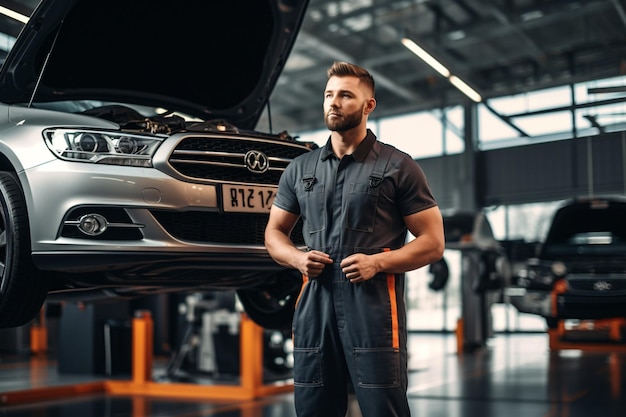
left=169, top=136, right=309, bottom=185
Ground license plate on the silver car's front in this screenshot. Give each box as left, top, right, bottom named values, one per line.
left=222, top=185, right=277, bottom=213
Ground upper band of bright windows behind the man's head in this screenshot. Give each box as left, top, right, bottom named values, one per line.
left=297, top=76, right=626, bottom=154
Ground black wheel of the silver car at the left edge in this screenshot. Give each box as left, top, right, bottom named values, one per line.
left=0, top=172, right=47, bottom=328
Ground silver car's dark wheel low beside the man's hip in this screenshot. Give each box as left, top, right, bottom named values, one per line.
left=237, top=271, right=302, bottom=330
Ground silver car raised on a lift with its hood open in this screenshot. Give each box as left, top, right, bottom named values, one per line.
left=0, top=0, right=312, bottom=327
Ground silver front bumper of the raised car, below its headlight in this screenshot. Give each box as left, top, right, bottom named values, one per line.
left=18, top=132, right=302, bottom=288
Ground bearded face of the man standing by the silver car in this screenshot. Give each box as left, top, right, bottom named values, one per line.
left=324, top=76, right=376, bottom=132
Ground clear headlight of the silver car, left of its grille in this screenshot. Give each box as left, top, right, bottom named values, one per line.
left=43, top=129, right=164, bottom=167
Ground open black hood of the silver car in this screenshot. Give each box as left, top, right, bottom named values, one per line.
left=0, top=0, right=308, bottom=129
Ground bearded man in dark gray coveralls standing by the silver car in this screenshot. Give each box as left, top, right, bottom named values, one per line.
left=265, top=62, right=444, bottom=417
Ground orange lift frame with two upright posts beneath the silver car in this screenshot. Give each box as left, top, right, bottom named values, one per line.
left=0, top=310, right=293, bottom=408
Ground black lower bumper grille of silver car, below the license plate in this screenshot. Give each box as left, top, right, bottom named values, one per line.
left=152, top=210, right=304, bottom=246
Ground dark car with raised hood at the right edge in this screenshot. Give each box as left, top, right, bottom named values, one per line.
left=509, top=197, right=626, bottom=328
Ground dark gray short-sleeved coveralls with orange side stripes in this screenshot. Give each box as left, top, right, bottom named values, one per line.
left=274, top=130, right=436, bottom=417
